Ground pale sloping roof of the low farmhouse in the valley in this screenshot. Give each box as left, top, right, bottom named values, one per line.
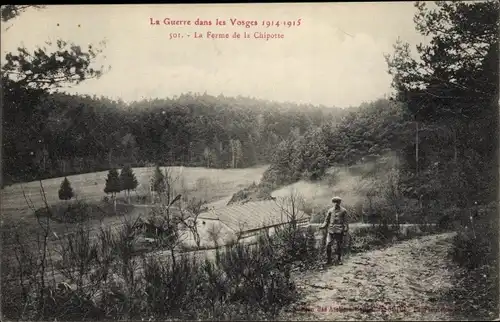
left=198, top=200, right=309, bottom=231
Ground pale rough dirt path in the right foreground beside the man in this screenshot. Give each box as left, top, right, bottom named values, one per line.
left=282, top=233, right=453, bottom=321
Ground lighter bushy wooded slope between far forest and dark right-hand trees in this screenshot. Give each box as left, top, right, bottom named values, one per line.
left=263, top=99, right=411, bottom=185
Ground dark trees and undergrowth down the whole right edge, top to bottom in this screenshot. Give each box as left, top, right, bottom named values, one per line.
left=386, top=1, right=500, bottom=319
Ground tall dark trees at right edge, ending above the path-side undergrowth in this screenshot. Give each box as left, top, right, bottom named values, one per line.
left=386, top=1, right=499, bottom=200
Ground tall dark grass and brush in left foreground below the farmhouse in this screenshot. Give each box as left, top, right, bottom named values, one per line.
left=2, top=200, right=320, bottom=321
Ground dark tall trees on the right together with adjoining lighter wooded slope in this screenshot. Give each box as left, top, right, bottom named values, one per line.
left=265, top=2, right=498, bottom=207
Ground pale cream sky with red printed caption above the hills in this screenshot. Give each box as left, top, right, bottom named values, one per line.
left=1, top=2, right=425, bottom=107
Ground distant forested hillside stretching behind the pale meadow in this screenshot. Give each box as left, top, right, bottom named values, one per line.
left=3, top=88, right=345, bottom=186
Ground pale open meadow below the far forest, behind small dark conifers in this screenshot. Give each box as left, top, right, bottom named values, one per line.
left=1, top=166, right=266, bottom=219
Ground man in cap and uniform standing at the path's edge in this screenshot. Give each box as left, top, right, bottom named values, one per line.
left=320, top=197, right=349, bottom=265
